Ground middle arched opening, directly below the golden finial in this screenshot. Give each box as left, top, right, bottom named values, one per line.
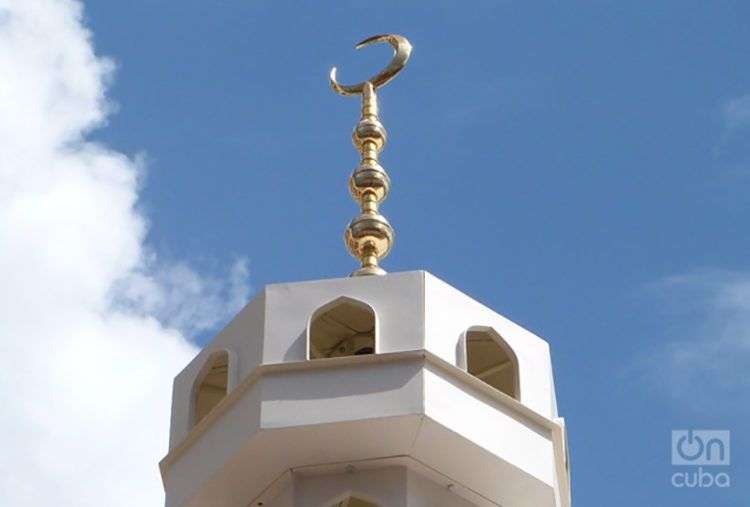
left=308, top=298, right=375, bottom=359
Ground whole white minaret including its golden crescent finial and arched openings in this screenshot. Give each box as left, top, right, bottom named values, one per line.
left=160, top=35, right=571, bottom=507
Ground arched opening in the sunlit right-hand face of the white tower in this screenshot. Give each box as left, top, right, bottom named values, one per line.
left=466, top=327, right=520, bottom=400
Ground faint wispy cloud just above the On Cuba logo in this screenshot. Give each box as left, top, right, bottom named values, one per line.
left=643, top=270, right=750, bottom=413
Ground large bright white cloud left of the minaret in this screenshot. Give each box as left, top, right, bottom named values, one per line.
left=0, top=0, right=253, bottom=507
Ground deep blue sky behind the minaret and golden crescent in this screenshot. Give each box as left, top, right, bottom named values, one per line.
left=0, top=0, right=750, bottom=507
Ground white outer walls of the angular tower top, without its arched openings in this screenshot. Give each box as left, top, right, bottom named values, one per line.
left=161, top=271, right=569, bottom=507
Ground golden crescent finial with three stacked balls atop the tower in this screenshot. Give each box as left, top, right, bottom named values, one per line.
left=331, top=35, right=411, bottom=276
